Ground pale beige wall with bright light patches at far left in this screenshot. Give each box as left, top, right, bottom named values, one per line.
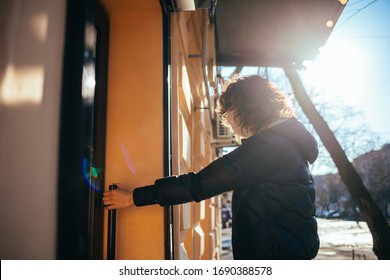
left=0, top=0, right=66, bottom=260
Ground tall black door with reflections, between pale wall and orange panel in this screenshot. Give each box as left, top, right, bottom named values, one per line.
left=57, top=0, right=109, bottom=259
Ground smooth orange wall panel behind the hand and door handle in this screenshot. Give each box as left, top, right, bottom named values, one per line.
left=103, top=0, right=164, bottom=259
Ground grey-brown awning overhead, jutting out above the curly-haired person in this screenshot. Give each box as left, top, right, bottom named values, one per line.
left=215, top=0, right=346, bottom=67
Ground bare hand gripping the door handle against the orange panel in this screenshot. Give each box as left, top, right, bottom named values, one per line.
left=103, top=184, right=134, bottom=210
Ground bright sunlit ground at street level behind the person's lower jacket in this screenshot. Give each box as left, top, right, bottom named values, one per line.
left=221, top=219, right=377, bottom=260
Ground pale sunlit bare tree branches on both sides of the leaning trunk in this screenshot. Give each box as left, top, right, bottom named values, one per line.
left=264, top=68, right=384, bottom=174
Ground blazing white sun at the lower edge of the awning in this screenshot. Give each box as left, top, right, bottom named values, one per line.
left=303, top=39, right=365, bottom=101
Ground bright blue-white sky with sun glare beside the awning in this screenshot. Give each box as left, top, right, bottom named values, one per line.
left=302, top=0, right=390, bottom=143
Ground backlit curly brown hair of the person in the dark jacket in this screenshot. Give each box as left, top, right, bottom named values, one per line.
left=216, top=75, right=294, bottom=139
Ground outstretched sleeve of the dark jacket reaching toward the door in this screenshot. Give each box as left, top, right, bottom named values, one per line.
left=133, top=132, right=288, bottom=206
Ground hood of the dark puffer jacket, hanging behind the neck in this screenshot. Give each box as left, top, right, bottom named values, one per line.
left=270, top=117, right=318, bottom=164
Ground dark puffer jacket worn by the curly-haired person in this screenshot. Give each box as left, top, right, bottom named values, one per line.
left=134, top=118, right=319, bottom=259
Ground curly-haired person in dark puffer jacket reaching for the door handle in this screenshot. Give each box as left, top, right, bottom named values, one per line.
left=103, top=76, right=319, bottom=259
